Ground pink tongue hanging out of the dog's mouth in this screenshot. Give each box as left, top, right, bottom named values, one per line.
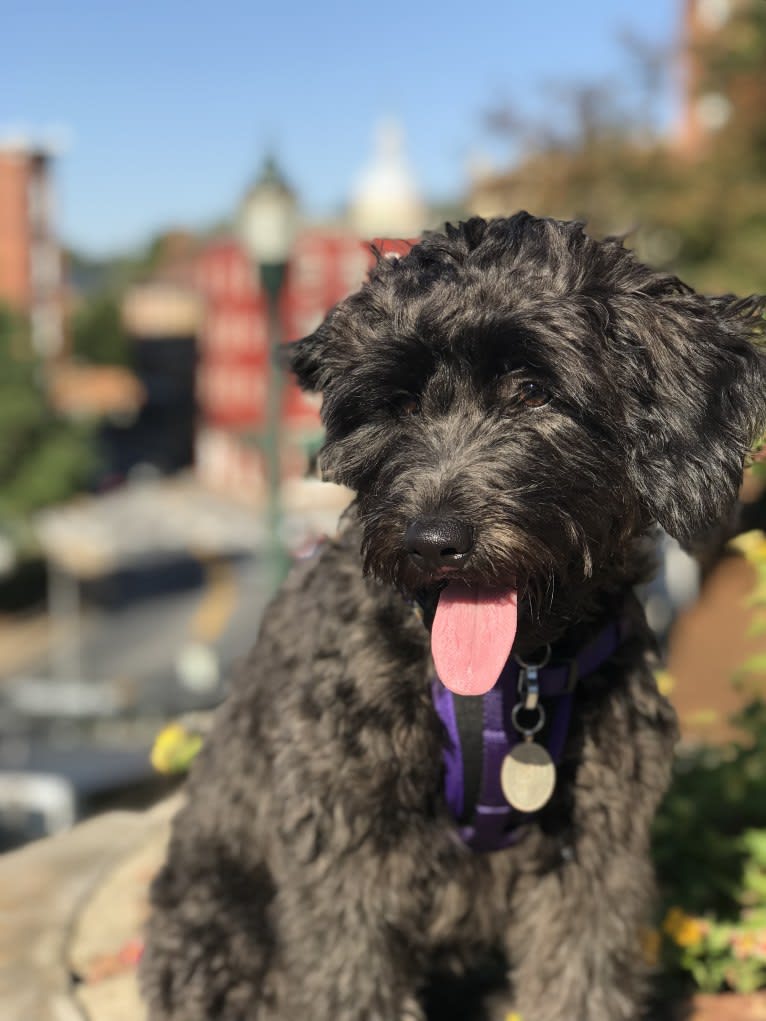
left=431, top=582, right=516, bottom=695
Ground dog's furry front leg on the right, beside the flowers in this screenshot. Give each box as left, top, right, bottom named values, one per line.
left=507, top=672, right=676, bottom=1021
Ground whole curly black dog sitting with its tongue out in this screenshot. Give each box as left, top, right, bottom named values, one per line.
left=142, top=212, right=766, bottom=1021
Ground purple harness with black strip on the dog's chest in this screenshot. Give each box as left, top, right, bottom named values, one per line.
left=432, top=617, right=628, bottom=850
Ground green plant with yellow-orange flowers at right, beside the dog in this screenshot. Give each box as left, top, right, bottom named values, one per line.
left=654, top=532, right=766, bottom=992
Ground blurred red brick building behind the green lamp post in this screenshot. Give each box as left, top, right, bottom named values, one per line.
left=195, top=228, right=409, bottom=498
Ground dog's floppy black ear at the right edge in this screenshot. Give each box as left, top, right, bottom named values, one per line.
left=629, top=289, right=766, bottom=545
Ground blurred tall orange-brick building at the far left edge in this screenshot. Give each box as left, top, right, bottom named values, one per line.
left=0, top=143, right=63, bottom=357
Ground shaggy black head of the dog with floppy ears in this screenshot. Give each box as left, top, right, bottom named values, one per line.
left=291, top=212, right=766, bottom=694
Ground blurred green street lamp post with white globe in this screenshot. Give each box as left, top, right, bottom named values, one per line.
left=239, top=157, right=297, bottom=590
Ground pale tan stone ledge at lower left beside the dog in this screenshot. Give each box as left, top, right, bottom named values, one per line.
left=0, top=798, right=178, bottom=1021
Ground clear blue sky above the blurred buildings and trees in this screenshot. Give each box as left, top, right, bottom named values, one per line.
left=0, top=0, right=681, bottom=254
